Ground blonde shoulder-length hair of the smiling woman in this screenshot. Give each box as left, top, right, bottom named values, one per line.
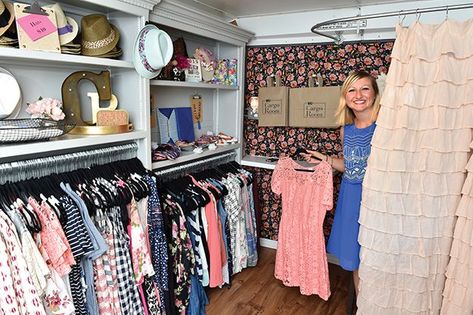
left=335, top=71, right=380, bottom=126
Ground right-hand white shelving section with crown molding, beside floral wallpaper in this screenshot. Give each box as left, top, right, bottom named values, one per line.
left=150, top=0, right=253, bottom=169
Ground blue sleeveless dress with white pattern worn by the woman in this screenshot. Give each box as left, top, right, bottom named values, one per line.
left=327, top=123, right=376, bottom=271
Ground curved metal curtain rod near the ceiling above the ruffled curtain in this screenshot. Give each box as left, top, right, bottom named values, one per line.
left=310, top=3, right=473, bottom=44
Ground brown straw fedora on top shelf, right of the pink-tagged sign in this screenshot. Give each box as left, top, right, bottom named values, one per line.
left=81, top=14, right=120, bottom=56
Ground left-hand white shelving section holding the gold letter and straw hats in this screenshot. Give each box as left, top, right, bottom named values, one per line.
left=0, top=0, right=159, bottom=168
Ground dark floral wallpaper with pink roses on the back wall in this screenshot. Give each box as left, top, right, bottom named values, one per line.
left=244, top=41, right=394, bottom=240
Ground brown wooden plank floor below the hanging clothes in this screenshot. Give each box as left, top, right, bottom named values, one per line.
left=207, top=248, right=351, bottom=315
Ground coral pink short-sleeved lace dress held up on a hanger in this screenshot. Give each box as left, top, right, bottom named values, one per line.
left=271, top=158, right=333, bottom=300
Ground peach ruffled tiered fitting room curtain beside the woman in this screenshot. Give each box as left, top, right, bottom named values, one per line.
left=357, top=20, right=473, bottom=315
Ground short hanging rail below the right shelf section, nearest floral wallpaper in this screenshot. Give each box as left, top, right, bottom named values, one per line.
left=154, top=151, right=236, bottom=182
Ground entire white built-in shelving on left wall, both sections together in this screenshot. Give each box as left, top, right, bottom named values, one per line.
left=0, top=0, right=253, bottom=173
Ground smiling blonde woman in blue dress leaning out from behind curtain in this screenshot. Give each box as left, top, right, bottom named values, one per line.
left=304, top=71, right=379, bottom=292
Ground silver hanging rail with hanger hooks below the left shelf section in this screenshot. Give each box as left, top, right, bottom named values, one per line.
left=0, top=142, right=138, bottom=184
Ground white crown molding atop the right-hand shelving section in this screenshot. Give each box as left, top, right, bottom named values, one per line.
left=150, top=0, right=254, bottom=45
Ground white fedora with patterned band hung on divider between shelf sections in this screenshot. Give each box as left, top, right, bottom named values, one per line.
left=133, top=24, right=173, bottom=79
